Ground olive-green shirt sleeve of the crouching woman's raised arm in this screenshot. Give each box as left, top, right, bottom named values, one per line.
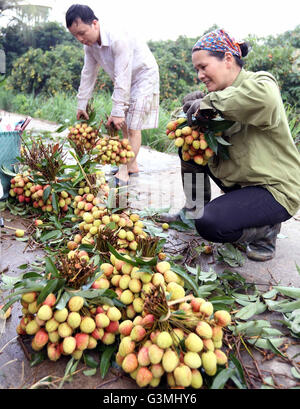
left=200, top=75, right=281, bottom=129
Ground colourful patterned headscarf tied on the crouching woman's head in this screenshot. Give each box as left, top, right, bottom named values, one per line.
left=192, top=30, right=242, bottom=58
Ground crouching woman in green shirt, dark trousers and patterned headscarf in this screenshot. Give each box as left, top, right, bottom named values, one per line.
left=162, top=30, right=300, bottom=261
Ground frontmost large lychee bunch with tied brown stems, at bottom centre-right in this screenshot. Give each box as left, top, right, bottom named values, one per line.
left=116, top=282, right=231, bottom=389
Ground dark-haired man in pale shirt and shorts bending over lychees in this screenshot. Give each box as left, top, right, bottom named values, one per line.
left=66, top=4, right=159, bottom=183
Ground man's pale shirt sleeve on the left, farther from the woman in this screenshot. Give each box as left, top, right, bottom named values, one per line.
left=77, top=47, right=100, bottom=110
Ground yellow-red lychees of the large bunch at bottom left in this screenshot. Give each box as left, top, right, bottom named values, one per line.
left=17, top=292, right=121, bottom=361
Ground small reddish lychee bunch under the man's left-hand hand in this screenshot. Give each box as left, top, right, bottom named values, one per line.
left=68, top=122, right=98, bottom=152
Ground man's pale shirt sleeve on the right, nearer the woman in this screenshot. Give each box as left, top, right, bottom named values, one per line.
left=111, top=39, right=133, bottom=117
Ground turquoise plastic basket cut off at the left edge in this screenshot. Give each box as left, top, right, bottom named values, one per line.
left=0, top=131, right=21, bottom=201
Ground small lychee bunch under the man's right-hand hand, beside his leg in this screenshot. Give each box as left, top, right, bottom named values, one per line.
left=94, top=136, right=135, bottom=165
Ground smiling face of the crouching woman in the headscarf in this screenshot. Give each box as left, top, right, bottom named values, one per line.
left=192, top=50, right=236, bottom=92
